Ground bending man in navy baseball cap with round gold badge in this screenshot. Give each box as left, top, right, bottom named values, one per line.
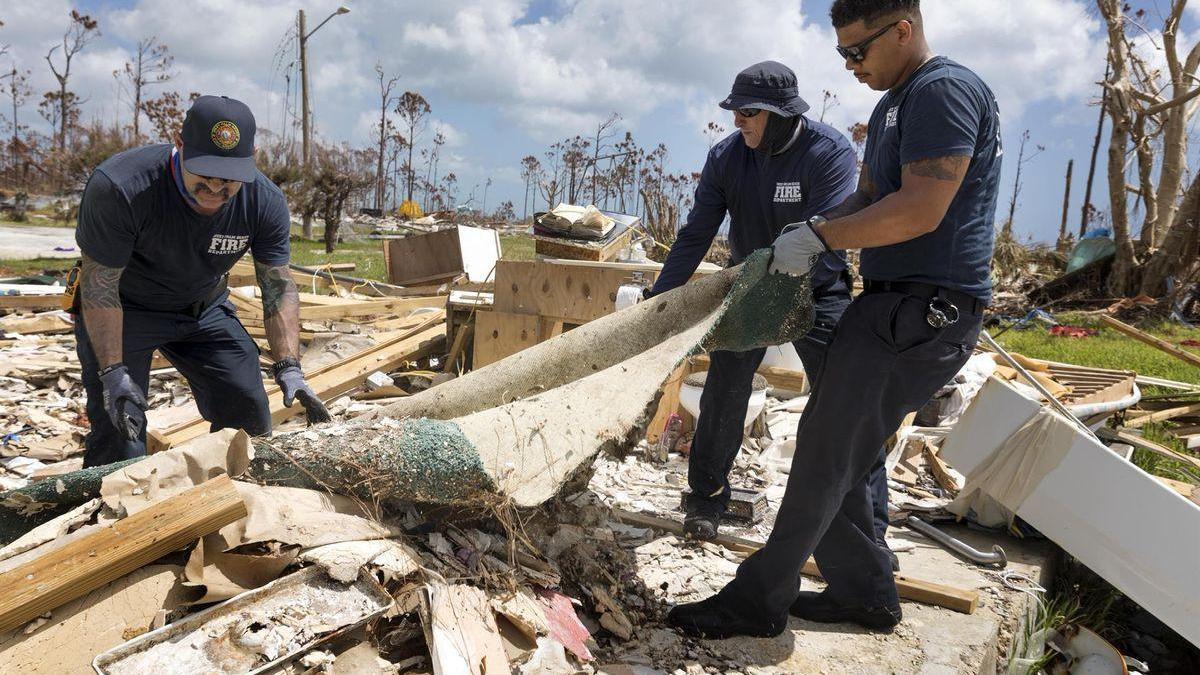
left=76, top=96, right=329, bottom=466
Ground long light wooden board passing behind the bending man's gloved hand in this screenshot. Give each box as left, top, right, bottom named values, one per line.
left=150, top=312, right=445, bottom=452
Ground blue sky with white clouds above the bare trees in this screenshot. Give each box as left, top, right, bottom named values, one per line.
left=0, top=0, right=1200, bottom=241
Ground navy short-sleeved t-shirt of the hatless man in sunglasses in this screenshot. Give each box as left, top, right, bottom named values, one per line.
left=859, top=56, right=1003, bottom=301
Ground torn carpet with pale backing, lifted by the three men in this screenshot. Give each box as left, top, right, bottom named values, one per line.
left=250, top=251, right=812, bottom=507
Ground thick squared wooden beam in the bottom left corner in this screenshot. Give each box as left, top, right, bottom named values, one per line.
left=0, top=474, right=246, bottom=633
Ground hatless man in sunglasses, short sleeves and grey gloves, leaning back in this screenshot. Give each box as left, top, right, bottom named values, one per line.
left=668, top=0, right=1001, bottom=638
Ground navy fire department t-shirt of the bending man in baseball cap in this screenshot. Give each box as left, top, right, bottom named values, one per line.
left=76, top=145, right=290, bottom=311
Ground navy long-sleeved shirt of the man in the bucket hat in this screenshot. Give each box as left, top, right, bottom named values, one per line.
left=653, top=118, right=858, bottom=294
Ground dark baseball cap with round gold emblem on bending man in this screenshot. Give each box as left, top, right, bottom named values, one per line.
left=181, top=96, right=258, bottom=183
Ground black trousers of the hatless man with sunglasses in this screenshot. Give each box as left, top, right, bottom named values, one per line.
left=720, top=285, right=983, bottom=612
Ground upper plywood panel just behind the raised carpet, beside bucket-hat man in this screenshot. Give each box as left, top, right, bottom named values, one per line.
left=493, top=261, right=658, bottom=323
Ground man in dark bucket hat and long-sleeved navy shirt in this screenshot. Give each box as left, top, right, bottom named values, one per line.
left=647, top=61, right=894, bottom=566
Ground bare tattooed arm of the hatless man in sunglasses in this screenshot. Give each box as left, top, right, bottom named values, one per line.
left=816, top=155, right=971, bottom=249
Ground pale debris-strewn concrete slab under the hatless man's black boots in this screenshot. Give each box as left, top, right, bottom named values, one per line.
left=592, top=451, right=1057, bottom=674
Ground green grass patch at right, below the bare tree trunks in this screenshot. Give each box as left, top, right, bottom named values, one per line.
left=991, top=313, right=1200, bottom=384
